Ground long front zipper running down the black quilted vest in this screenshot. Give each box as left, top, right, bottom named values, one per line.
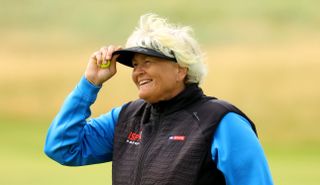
left=134, top=115, right=161, bottom=185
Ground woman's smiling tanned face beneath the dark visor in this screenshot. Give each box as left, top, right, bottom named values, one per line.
left=132, top=53, right=187, bottom=103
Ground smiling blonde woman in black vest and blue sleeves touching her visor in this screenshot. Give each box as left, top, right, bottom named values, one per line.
left=45, top=14, right=273, bottom=185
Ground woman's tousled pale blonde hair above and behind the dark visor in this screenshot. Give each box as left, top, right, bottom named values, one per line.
left=126, top=14, right=207, bottom=83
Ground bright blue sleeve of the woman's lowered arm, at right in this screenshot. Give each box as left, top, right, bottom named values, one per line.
left=211, top=113, right=273, bottom=185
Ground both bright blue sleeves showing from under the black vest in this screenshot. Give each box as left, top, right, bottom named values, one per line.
left=45, top=77, right=273, bottom=185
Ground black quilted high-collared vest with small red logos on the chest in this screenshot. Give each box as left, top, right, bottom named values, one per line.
left=112, top=84, right=256, bottom=185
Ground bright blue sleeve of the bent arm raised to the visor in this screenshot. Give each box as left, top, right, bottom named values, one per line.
left=44, top=77, right=122, bottom=166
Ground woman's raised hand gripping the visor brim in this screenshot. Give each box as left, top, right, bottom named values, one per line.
left=85, top=45, right=121, bottom=85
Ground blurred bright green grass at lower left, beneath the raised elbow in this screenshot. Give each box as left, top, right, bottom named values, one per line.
left=0, top=118, right=111, bottom=185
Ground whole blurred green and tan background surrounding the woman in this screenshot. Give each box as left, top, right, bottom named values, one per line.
left=0, top=0, right=320, bottom=185
